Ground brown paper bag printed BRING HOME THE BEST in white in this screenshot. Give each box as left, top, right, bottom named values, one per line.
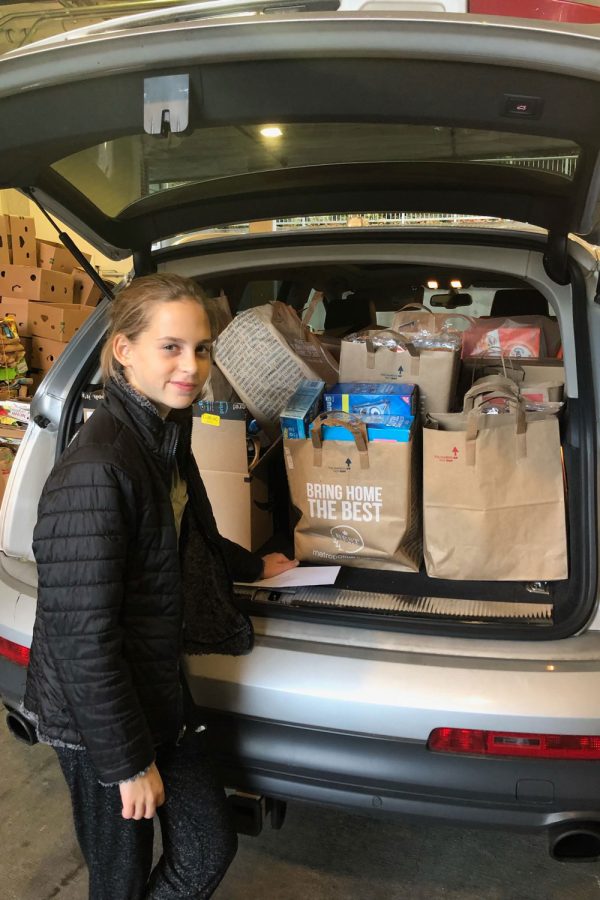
left=284, top=414, right=422, bottom=572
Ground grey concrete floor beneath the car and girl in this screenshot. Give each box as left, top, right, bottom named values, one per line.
left=0, top=717, right=600, bottom=900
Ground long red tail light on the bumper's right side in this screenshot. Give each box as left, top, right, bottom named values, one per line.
left=427, top=728, right=600, bottom=759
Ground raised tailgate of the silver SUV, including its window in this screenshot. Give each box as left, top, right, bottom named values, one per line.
left=0, top=13, right=600, bottom=256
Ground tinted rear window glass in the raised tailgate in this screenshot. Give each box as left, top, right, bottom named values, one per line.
left=52, top=122, right=579, bottom=216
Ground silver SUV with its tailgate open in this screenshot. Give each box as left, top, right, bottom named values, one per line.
left=0, top=12, right=600, bottom=858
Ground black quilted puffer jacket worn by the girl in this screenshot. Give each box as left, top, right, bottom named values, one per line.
left=24, top=380, right=262, bottom=784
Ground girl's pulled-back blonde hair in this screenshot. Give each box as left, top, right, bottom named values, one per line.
left=100, top=272, right=214, bottom=381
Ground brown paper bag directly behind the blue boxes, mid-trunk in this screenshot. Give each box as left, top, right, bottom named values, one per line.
left=340, top=330, right=460, bottom=415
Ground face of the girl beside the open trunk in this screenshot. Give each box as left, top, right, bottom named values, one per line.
left=113, top=297, right=212, bottom=418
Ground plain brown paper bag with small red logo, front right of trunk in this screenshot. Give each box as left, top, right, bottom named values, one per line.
left=423, top=376, right=568, bottom=581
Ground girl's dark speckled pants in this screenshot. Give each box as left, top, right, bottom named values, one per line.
left=56, top=732, right=237, bottom=900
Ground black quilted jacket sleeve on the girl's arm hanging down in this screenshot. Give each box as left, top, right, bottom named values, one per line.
left=33, top=458, right=154, bottom=784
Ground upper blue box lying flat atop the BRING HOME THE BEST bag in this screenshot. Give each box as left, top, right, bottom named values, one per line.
left=323, top=381, right=417, bottom=418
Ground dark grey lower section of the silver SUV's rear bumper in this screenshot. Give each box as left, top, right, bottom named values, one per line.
left=198, top=710, right=600, bottom=831
